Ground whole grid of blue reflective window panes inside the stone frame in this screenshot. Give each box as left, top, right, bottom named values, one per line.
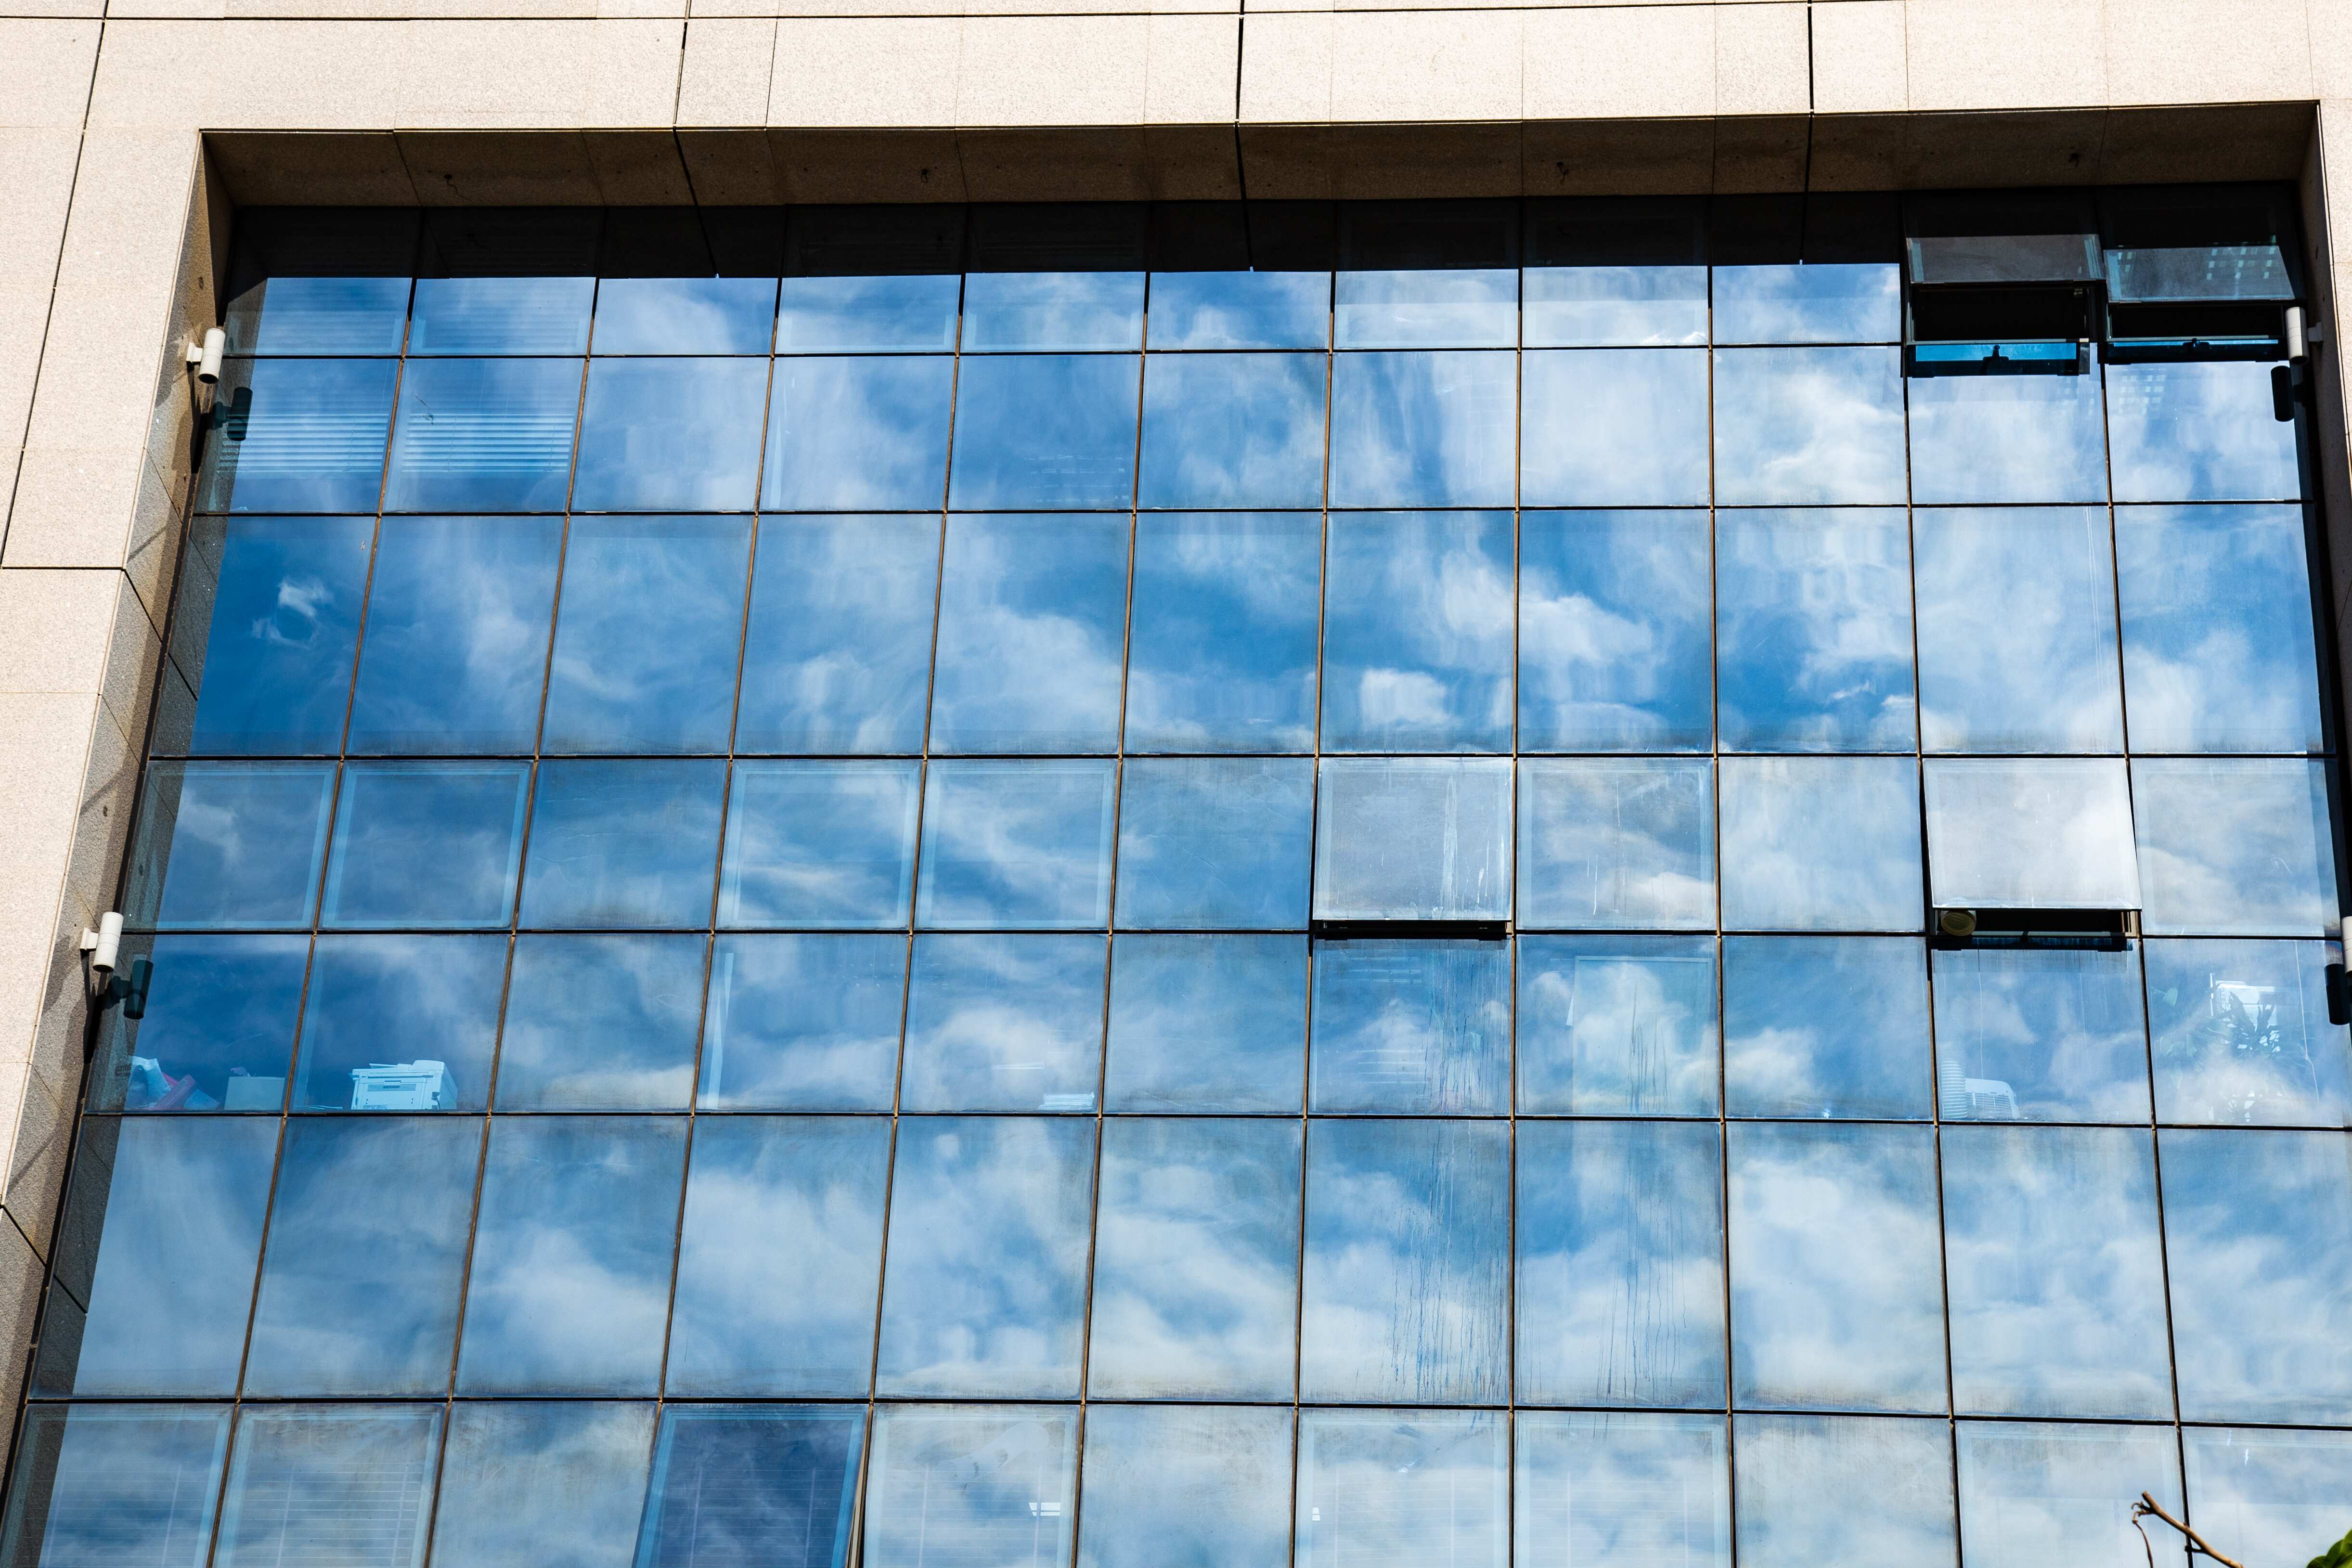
left=0, top=197, right=2352, bottom=1568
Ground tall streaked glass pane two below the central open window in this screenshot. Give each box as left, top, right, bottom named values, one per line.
left=1298, top=1121, right=1510, bottom=1401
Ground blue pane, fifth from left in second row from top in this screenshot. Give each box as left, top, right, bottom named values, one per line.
left=948, top=355, right=1141, bottom=510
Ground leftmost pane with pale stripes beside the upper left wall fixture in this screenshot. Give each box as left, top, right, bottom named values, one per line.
left=195, top=360, right=397, bottom=513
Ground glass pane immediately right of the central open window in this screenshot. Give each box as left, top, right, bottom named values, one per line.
left=1519, top=757, right=1715, bottom=931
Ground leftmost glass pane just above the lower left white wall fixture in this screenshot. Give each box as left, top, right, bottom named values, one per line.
left=122, top=762, right=334, bottom=931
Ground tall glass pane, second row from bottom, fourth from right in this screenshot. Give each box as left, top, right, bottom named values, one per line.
left=1512, top=1121, right=1724, bottom=1410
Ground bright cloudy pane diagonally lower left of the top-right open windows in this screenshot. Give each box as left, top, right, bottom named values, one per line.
left=1715, top=348, right=1905, bottom=505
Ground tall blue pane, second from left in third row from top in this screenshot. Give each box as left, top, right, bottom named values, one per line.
left=348, top=517, right=565, bottom=754
